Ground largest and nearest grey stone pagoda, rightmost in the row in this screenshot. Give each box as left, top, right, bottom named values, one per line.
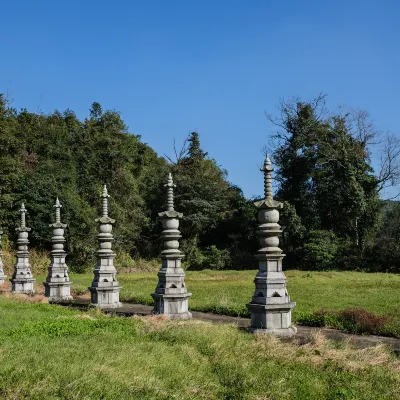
left=246, top=155, right=297, bottom=337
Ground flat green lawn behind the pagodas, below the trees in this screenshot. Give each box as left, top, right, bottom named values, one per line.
left=61, top=270, right=400, bottom=337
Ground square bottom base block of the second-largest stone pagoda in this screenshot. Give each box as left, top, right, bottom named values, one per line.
left=151, top=293, right=192, bottom=319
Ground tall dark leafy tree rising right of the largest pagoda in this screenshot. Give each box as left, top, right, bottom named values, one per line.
left=267, top=95, right=388, bottom=268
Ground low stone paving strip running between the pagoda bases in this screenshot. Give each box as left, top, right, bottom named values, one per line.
left=60, top=297, right=400, bottom=355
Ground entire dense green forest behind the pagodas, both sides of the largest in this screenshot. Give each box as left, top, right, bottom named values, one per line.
left=0, top=96, right=400, bottom=272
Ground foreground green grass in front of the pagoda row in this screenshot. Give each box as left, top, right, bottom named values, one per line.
left=0, top=296, right=400, bottom=400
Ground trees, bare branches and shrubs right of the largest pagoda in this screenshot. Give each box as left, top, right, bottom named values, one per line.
left=268, top=96, right=400, bottom=272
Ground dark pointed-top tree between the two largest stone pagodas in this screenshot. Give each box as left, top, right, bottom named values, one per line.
left=169, top=132, right=255, bottom=268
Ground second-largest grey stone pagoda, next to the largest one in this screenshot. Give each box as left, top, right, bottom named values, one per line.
left=151, top=174, right=192, bottom=319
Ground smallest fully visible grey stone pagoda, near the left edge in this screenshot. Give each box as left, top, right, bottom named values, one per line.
left=10, top=203, right=36, bottom=294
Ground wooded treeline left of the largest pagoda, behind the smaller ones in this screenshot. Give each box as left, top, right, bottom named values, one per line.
left=0, top=96, right=255, bottom=270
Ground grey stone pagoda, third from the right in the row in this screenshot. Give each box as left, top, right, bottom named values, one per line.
left=89, top=185, right=121, bottom=308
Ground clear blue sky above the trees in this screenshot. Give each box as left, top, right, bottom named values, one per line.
left=0, top=0, right=400, bottom=197
